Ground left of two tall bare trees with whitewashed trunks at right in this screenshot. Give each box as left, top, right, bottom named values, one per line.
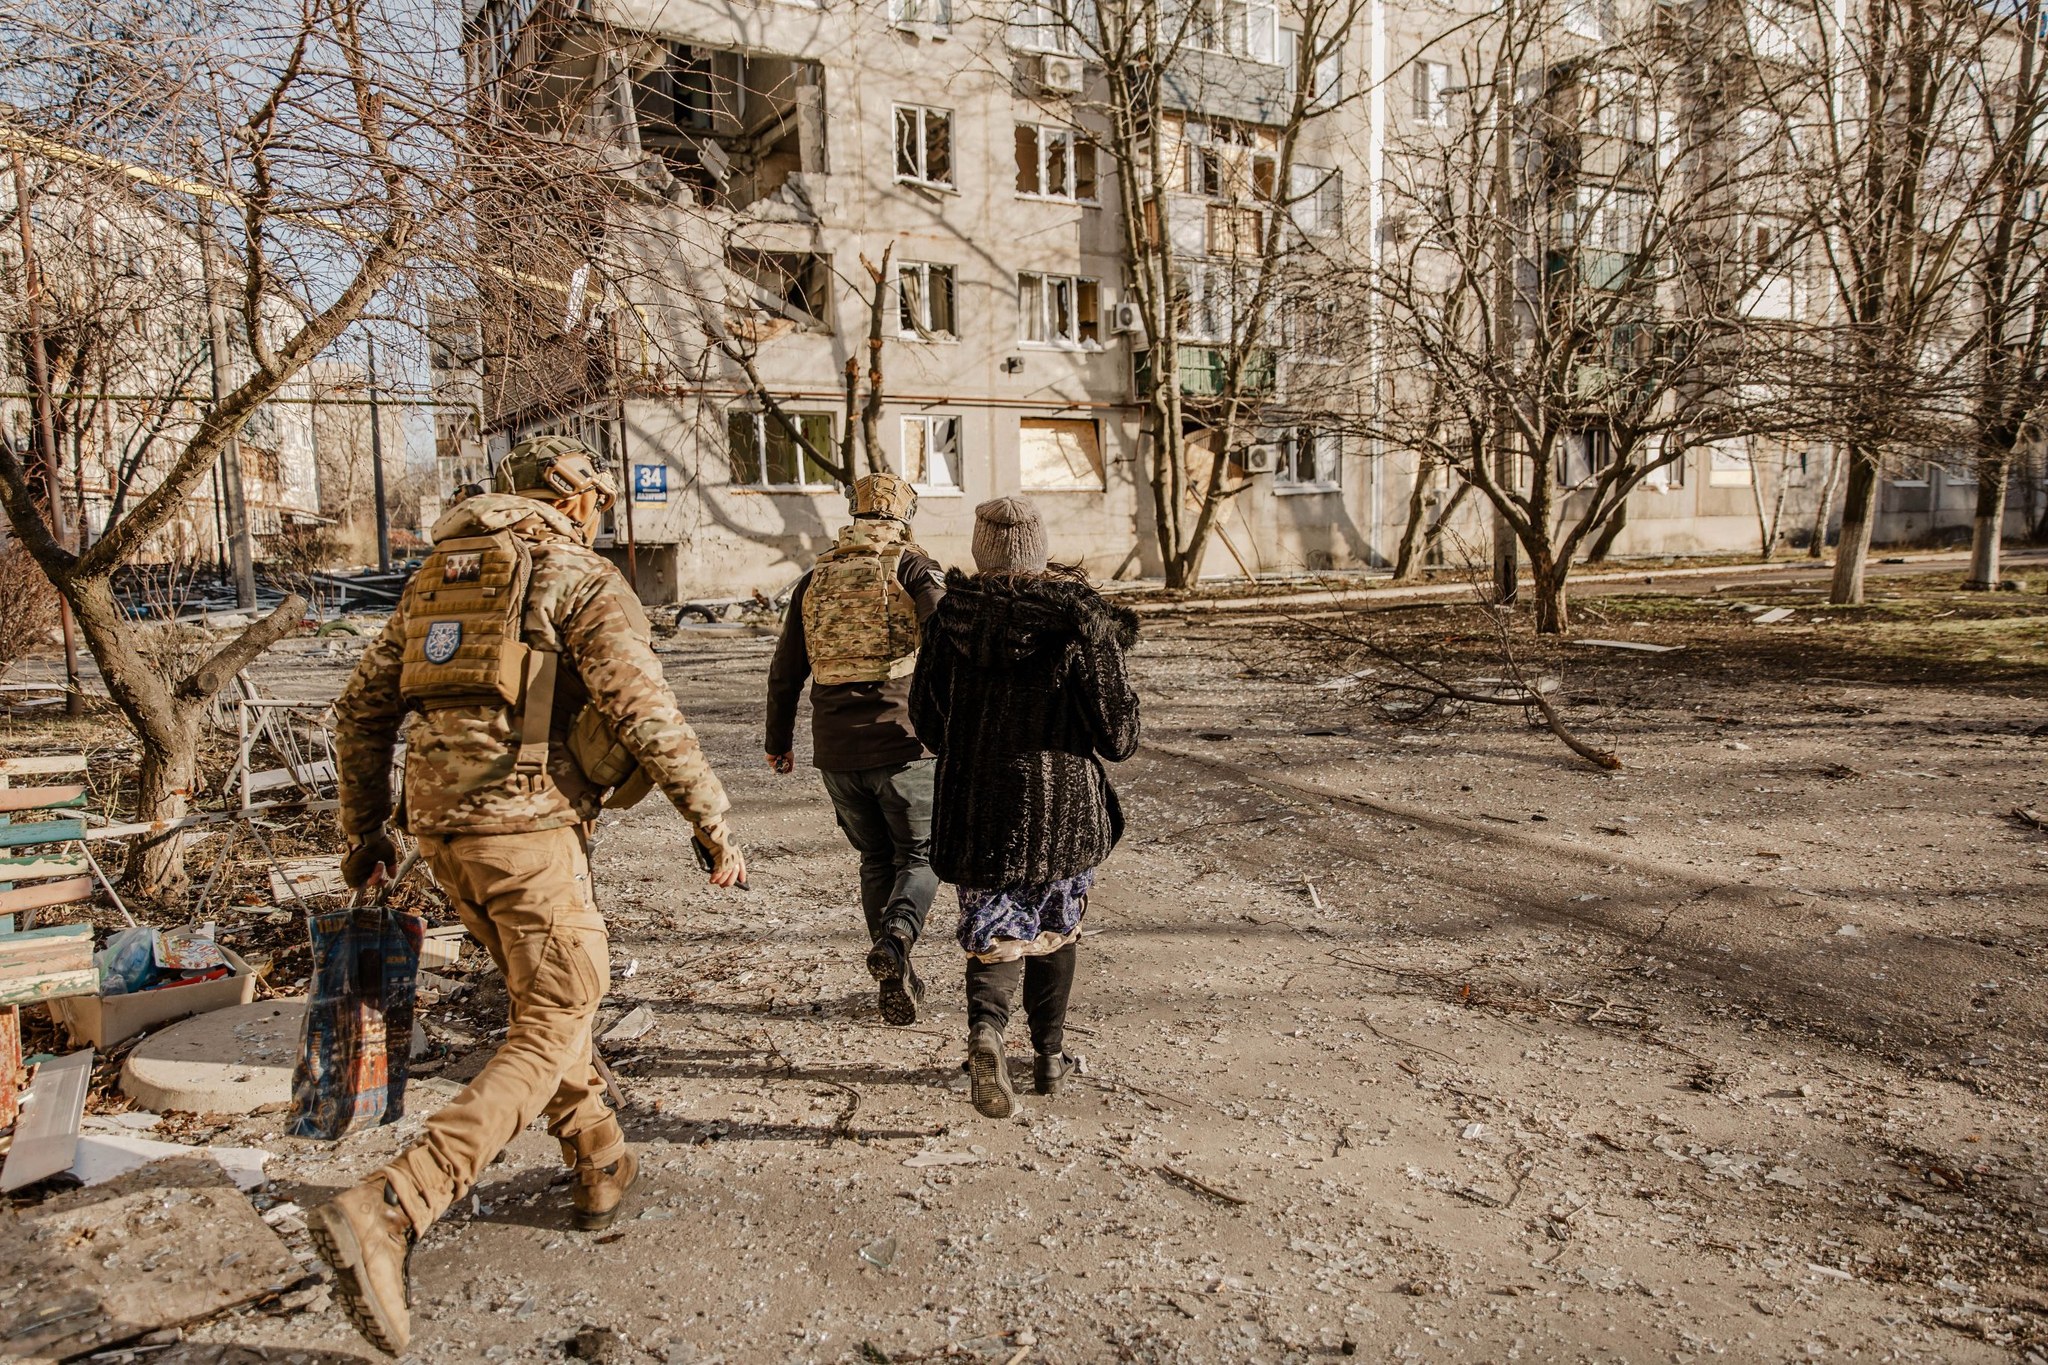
left=1785, top=0, right=2007, bottom=604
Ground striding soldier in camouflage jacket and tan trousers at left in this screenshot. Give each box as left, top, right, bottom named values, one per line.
left=309, top=436, right=745, bottom=1355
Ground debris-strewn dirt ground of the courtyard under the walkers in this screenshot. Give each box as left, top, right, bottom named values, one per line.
left=12, top=556, right=2048, bottom=1365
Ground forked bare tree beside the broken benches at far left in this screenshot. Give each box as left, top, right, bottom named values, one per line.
left=0, top=0, right=512, bottom=890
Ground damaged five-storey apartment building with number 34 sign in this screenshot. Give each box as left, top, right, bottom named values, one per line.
left=460, top=0, right=1966, bottom=602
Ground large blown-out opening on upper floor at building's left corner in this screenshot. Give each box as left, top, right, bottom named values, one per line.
left=633, top=41, right=827, bottom=209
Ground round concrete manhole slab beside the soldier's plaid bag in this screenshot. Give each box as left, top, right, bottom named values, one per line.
left=121, top=997, right=305, bottom=1113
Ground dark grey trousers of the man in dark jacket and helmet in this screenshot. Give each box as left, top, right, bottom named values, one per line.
left=817, top=759, right=938, bottom=943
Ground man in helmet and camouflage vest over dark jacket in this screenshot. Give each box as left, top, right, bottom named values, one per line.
left=768, top=475, right=946, bottom=1025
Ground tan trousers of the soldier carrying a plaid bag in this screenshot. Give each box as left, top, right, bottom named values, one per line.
left=381, top=825, right=625, bottom=1234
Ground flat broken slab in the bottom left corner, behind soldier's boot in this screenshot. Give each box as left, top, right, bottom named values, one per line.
left=0, top=1156, right=305, bottom=1365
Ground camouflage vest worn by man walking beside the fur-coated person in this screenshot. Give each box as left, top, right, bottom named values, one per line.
left=803, top=520, right=924, bottom=686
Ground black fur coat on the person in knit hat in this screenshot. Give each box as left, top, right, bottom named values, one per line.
left=909, top=569, right=1139, bottom=888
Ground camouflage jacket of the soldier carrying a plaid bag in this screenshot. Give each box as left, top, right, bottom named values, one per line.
left=334, top=493, right=727, bottom=835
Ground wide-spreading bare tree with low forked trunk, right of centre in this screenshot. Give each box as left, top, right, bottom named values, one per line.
left=1366, top=0, right=1798, bottom=632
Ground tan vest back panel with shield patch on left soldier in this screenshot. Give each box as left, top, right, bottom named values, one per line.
left=397, top=530, right=532, bottom=710
